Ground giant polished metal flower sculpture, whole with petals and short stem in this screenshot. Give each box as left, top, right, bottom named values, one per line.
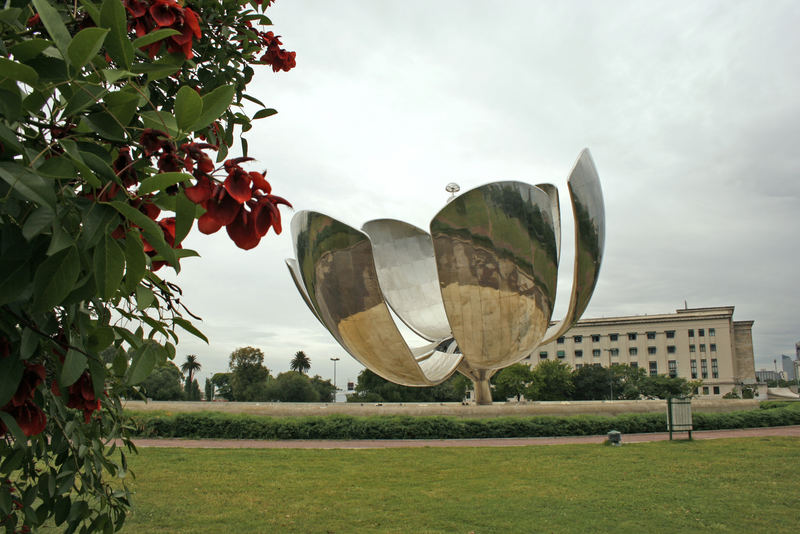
left=286, top=150, right=605, bottom=404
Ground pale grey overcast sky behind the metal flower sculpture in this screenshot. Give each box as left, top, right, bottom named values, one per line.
left=166, top=0, right=800, bottom=386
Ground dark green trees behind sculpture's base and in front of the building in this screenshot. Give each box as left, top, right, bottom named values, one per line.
left=347, top=360, right=700, bottom=402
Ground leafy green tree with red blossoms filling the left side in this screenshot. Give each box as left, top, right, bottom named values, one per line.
left=0, top=0, right=295, bottom=532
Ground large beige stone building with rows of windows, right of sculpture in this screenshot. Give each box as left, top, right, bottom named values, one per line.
left=525, top=306, right=756, bottom=396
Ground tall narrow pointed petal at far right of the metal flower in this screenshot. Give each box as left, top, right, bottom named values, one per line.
left=541, top=149, right=606, bottom=345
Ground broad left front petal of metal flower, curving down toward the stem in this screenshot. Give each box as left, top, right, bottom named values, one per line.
left=290, top=211, right=461, bottom=386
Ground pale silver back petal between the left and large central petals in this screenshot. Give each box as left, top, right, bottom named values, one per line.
left=362, top=219, right=451, bottom=341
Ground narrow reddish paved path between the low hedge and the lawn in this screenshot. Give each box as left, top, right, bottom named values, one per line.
left=134, top=425, right=800, bottom=449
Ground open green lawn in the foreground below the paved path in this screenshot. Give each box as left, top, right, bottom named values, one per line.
left=119, top=437, right=800, bottom=534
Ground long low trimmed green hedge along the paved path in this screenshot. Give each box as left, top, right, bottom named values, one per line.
left=132, top=403, right=800, bottom=439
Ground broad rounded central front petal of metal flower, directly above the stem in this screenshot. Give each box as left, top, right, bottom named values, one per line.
left=431, top=182, right=558, bottom=369
